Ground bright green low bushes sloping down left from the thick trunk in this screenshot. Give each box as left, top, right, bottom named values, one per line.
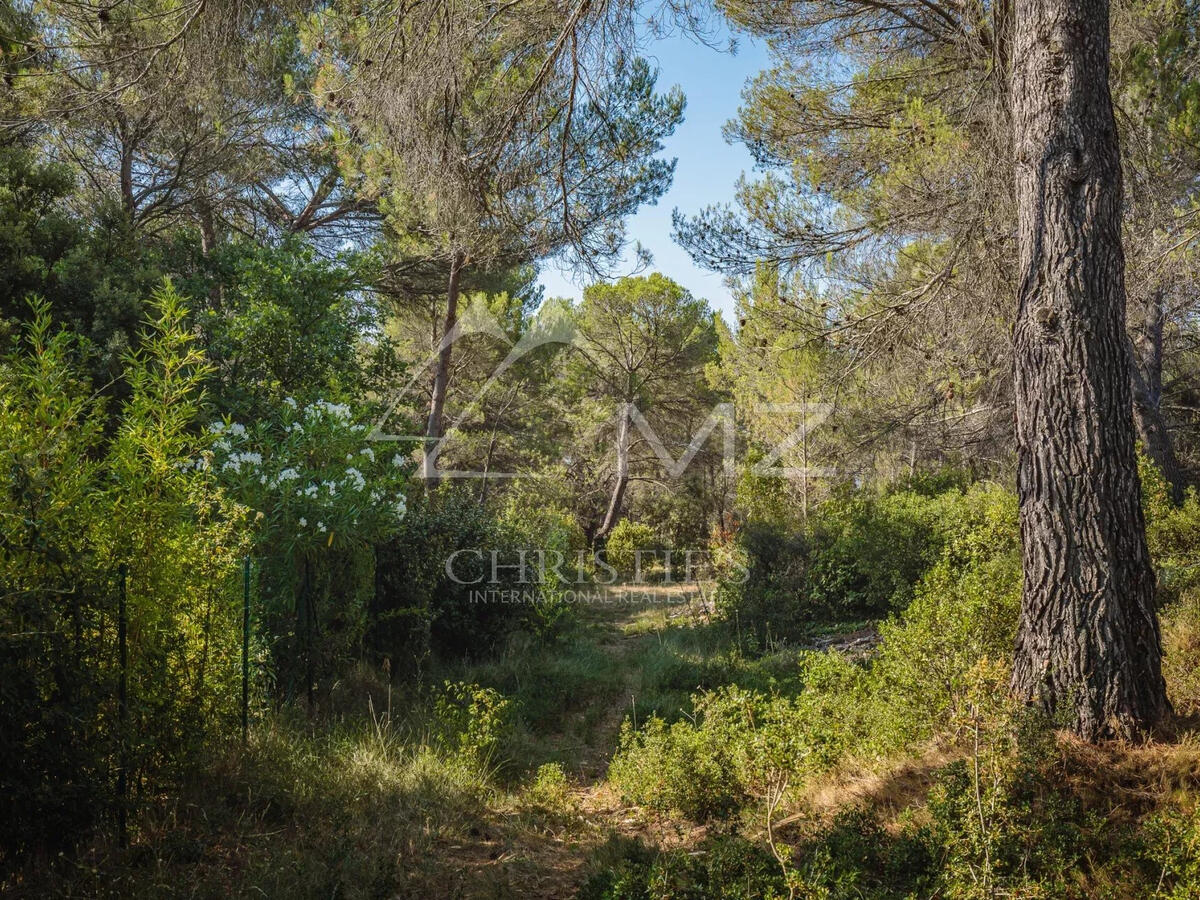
left=612, top=486, right=1020, bottom=818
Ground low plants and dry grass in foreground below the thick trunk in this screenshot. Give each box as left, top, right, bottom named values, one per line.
left=600, top=724, right=1200, bottom=900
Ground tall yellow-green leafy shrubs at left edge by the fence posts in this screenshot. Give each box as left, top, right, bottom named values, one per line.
left=0, top=292, right=248, bottom=852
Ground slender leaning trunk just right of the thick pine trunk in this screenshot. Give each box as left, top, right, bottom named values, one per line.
left=1133, top=288, right=1183, bottom=502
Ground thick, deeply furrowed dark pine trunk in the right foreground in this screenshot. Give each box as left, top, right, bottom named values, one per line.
left=1012, top=0, right=1170, bottom=740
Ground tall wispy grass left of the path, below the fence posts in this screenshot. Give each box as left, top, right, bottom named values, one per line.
left=8, top=715, right=499, bottom=898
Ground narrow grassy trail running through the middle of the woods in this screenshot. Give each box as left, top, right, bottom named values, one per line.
left=422, top=586, right=720, bottom=899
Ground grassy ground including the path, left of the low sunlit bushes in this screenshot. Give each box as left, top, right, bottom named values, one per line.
left=4, top=588, right=787, bottom=898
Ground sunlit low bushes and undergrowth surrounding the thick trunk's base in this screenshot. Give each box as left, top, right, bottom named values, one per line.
left=600, top=480, right=1200, bottom=900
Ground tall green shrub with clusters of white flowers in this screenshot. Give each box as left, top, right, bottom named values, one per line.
left=206, top=397, right=413, bottom=697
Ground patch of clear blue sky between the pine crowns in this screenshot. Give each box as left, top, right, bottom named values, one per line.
left=540, top=25, right=767, bottom=320
